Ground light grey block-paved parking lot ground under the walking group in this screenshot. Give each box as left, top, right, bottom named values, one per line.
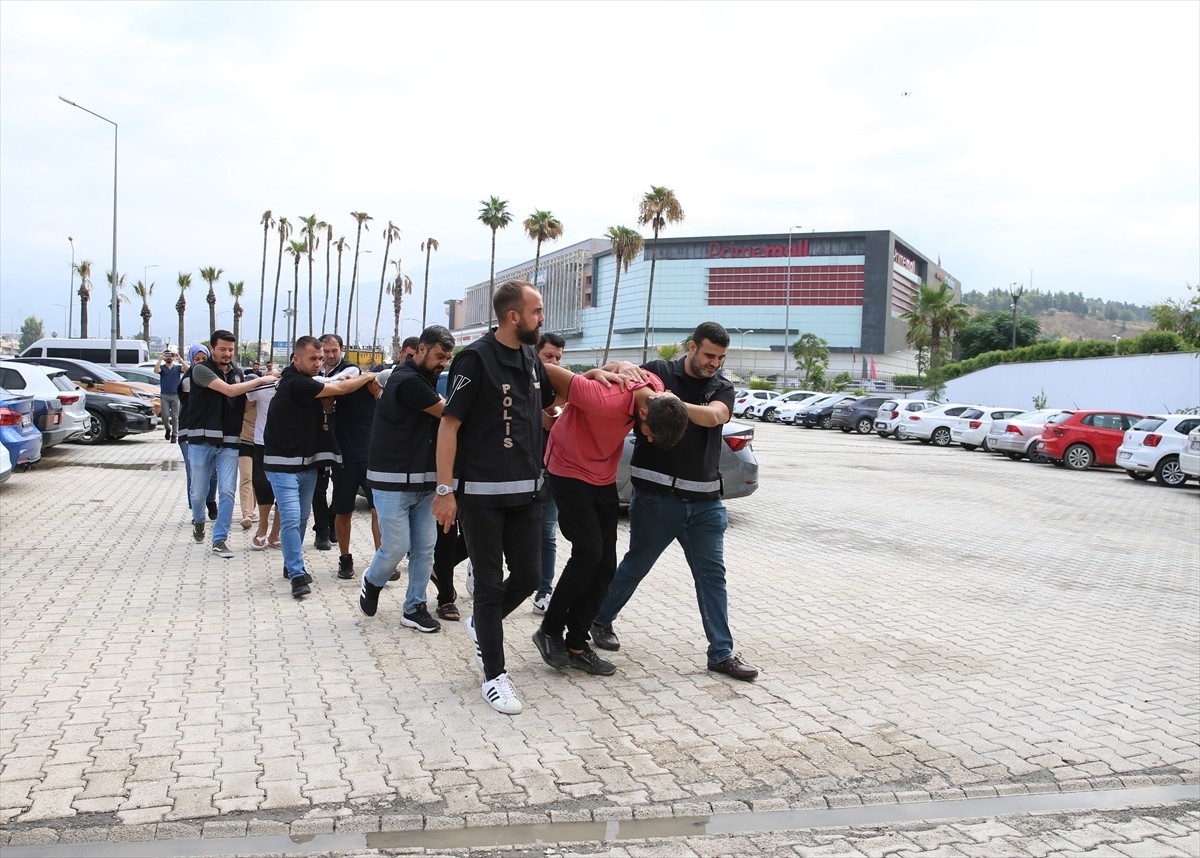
left=0, top=424, right=1200, bottom=854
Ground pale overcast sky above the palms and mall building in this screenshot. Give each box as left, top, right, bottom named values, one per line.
left=0, top=0, right=1200, bottom=340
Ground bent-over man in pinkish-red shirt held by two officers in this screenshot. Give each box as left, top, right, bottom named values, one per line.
left=533, top=374, right=688, bottom=676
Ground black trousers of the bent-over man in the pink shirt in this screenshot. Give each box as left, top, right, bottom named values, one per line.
left=541, top=474, right=619, bottom=650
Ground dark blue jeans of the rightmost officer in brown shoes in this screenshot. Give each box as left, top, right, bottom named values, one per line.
left=595, top=487, right=733, bottom=661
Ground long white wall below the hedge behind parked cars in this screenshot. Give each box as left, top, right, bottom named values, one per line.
left=926, top=353, right=1200, bottom=414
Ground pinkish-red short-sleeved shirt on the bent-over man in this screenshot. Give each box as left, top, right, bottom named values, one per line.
left=546, top=374, right=665, bottom=486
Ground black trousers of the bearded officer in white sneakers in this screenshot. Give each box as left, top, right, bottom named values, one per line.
left=458, top=500, right=541, bottom=680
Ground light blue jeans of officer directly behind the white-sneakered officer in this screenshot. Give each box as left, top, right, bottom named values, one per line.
left=362, top=488, right=438, bottom=613
